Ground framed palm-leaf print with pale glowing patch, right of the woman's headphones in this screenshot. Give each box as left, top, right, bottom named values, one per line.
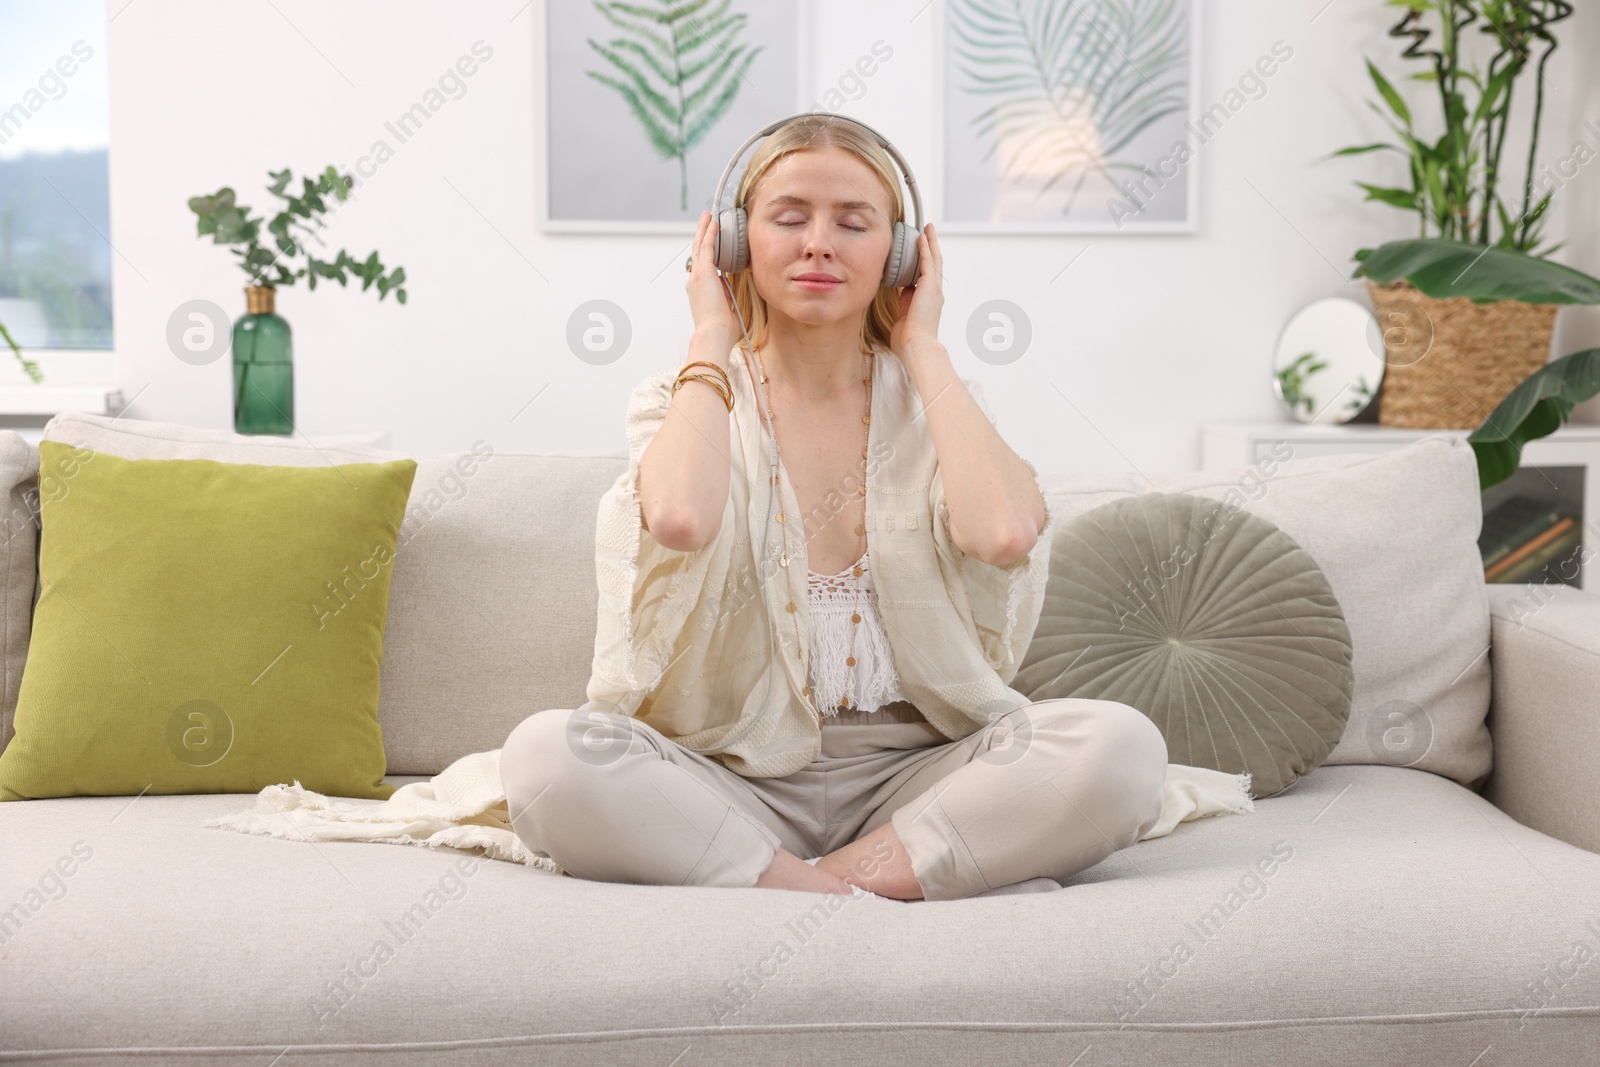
left=933, top=0, right=1200, bottom=234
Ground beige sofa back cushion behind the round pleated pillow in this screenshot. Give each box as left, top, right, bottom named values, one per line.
left=1040, top=435, right=1491, bottom=789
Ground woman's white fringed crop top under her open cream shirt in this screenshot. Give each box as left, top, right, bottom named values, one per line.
left=806, top=552, right=909, bottom=715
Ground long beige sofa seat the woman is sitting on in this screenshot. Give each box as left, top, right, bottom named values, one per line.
left=0, top=765, right=1600, bottom=1067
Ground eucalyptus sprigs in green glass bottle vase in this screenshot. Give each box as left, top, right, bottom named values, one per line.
left=189, top=166, right=405, bottom=434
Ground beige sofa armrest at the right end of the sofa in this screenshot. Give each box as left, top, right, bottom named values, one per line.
left=1483, top=585, right=1600, bottom=853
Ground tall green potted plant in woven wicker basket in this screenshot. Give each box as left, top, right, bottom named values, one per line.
left=1330, top=0, right=1600, bottom=429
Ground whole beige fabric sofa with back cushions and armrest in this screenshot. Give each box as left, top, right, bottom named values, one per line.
left=0, top=414, right=1600, bottom=1067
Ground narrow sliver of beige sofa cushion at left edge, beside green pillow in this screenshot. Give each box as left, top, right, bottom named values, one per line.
left=0, top=430, right=38, bottom=764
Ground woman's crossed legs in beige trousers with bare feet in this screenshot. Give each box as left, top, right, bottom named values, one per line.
left=501, top=697, right=1166, bottom=901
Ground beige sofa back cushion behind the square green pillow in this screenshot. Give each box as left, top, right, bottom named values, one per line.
left=45, top=413, right=627, bottom=774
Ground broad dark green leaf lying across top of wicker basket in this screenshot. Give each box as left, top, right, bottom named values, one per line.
left=1350, top=237, right=1600, bottom=304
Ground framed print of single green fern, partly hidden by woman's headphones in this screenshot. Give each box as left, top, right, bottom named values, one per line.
left=536, top=0, right=808, bottom=235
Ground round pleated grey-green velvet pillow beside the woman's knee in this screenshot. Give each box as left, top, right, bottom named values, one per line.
left=1011, top=493, right=1355, bottom=797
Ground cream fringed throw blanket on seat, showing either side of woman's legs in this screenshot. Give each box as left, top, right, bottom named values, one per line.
left=205, top=749, right=1256, bottom=875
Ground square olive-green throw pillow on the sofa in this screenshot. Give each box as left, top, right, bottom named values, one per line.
left=0, top=440, right=416, bottom=800
